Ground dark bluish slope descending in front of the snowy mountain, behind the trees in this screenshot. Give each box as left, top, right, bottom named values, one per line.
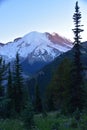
left=30, top=42, right=87, bottom=93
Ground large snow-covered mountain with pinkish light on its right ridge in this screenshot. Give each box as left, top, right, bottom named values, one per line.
left=0, top=32, right=72, bottom=74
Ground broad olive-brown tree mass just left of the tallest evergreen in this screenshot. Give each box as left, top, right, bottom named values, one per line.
left=46, top=59, right=71, bottom=109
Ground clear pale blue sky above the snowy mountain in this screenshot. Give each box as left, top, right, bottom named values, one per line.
left=0, top=0, right=87, bottom=43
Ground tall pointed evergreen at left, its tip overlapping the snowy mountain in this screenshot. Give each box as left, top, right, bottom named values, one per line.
left=13, top=53, right=24, bottom=113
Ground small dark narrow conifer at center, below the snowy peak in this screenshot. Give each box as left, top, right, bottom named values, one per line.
left=35, top=85, right=43, bottom=113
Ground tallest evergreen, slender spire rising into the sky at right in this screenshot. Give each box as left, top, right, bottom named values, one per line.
left=70, top=2, right=84, bottom=112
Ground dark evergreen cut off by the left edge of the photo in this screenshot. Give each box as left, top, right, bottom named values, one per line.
left=0, top=57, right=9, bottom=118
